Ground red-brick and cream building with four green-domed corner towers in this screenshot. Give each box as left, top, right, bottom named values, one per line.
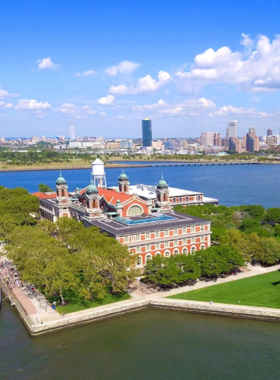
left=34, top=163, right=214, bottom=268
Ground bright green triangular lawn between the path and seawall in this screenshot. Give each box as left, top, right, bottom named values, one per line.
left=168, top=271, right=280, bottom=309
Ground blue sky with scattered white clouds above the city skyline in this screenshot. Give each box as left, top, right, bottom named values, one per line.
left=0, top=0, right=280, bottom=137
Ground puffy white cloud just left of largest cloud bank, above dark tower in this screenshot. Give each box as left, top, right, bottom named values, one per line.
left=109, top=71, right=172, bottom=95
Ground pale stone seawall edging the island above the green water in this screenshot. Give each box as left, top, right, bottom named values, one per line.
left=0, top=292, right=280, bottom=337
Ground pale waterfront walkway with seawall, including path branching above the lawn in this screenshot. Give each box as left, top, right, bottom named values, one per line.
left=0, top=249, right=280, bottom=335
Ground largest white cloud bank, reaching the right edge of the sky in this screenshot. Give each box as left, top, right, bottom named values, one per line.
left=175, top=33, right=280, bottom=92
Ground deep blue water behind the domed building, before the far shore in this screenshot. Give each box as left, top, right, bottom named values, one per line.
left=0, top=163, right=280, bottom=208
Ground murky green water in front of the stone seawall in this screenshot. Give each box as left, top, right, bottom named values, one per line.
left=0, top=304, right=280, bottom=380
